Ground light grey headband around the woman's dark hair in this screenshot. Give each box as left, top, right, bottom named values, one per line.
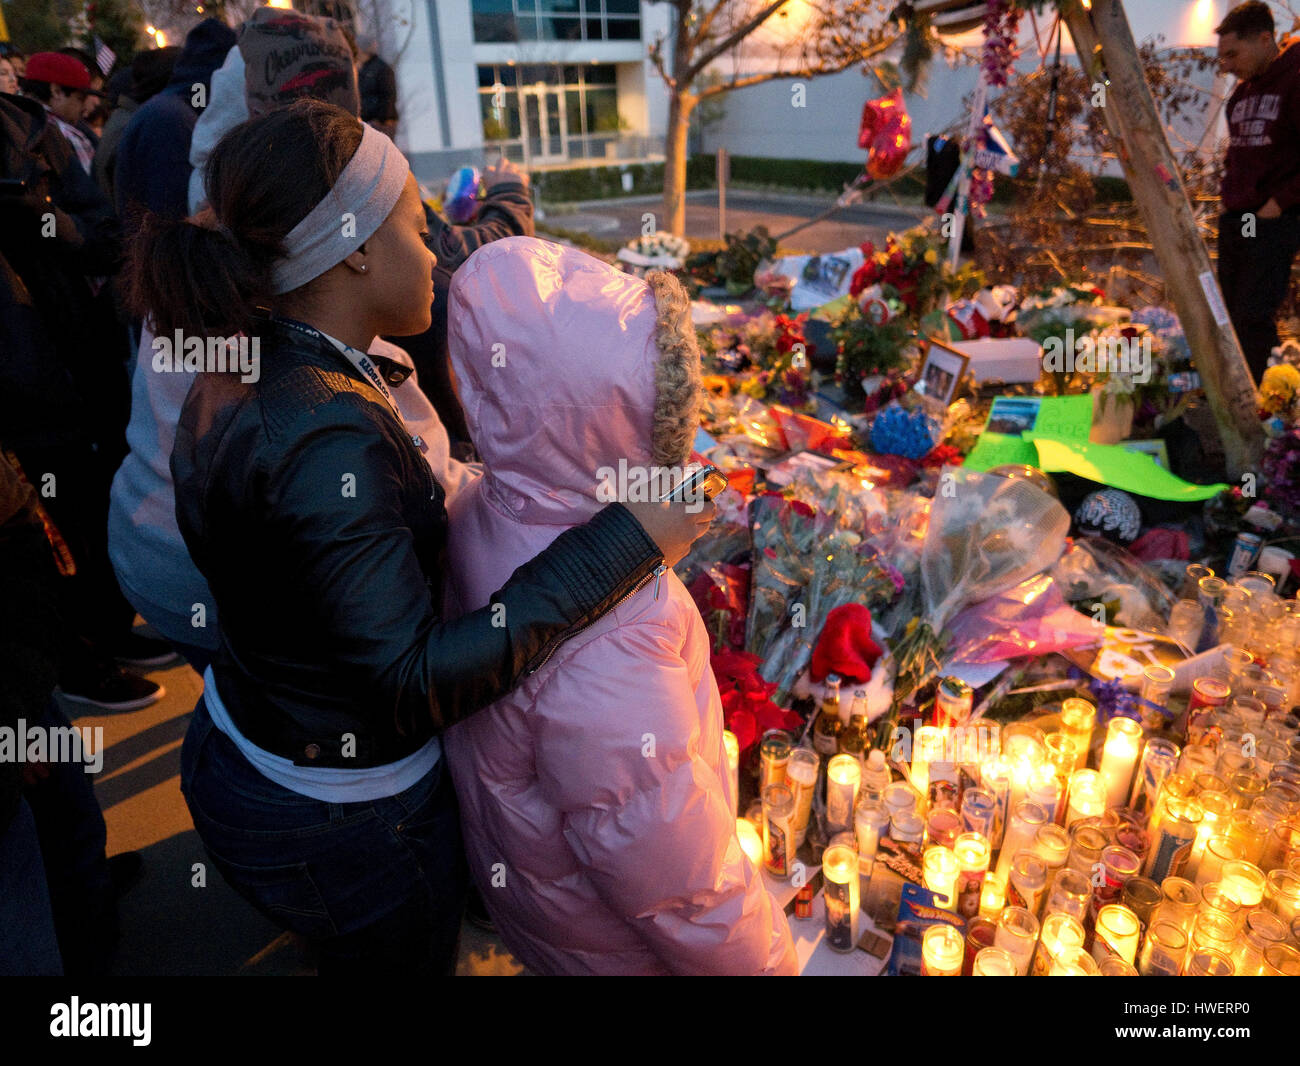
left=272, top=125, right=411, bottom=295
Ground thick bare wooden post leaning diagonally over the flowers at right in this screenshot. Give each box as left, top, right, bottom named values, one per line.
left=1062, top=0, right=1264, bottom=478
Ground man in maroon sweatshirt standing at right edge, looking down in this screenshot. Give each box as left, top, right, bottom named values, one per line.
left=1217, top=0, right=1300, bottom=380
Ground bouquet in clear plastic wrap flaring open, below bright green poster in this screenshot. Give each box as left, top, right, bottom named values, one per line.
left=878, top=467, right=1070, bottom=737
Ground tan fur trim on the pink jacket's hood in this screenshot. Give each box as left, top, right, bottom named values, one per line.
left=646, top=272, right=702, bottom=467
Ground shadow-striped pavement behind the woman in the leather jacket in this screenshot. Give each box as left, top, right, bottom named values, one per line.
left=62, top=642, right=523, bottom=976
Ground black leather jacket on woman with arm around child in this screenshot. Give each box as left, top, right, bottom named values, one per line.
left=172, top=321, right=663, bottom=767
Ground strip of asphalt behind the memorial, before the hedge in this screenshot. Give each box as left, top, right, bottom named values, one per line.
left=538, top=190, right=931, bottom=252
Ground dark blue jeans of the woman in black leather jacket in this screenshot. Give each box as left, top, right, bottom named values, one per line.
left=181, top=698, right=469, bottom=976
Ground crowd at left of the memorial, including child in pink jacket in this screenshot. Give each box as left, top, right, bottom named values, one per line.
left=0, top=8, right=794, bottom=975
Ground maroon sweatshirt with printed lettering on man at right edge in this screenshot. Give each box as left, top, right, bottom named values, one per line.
left=1221, top=40, right=1300, bottom=212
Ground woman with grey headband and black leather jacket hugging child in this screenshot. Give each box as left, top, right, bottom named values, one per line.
left=122, top=100, right=711, bottom=974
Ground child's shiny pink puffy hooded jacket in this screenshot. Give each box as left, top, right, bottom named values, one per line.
left=445, top=237, right=797, bottom=974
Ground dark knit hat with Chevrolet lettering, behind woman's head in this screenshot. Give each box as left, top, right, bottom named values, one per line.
left=239, top=8, right=361, bottom=117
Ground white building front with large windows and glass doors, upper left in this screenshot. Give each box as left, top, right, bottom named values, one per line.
left=380, top=0, right=671, bottom=182
